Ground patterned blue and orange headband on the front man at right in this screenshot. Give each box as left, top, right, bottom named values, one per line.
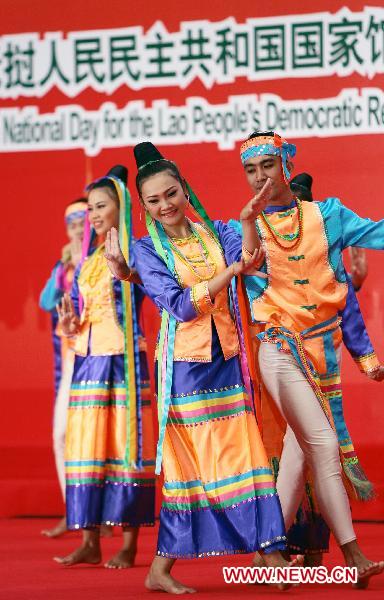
left=240, top=131, right=296, bottom=183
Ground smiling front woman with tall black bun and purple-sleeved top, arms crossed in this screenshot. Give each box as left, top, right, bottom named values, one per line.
left=107, top=142, right=300, bottom=594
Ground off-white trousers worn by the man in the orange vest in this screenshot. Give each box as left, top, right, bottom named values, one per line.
left=259, top=343, right=356, bottom=546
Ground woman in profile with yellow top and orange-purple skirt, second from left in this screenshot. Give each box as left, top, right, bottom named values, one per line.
left=55, top=165, right=155, bottom=569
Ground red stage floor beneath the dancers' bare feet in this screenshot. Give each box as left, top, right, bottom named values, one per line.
left=0, top=518, right=384, bottom=600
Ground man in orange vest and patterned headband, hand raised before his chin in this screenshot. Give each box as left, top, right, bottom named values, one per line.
left=231, top=132, right=384, bottom=585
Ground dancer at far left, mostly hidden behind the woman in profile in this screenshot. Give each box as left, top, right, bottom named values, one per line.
left=40, top=198, right=87, bottom=537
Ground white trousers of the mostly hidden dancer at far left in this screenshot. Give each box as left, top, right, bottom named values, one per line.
left=53, top=350, right=75, bottom=503
